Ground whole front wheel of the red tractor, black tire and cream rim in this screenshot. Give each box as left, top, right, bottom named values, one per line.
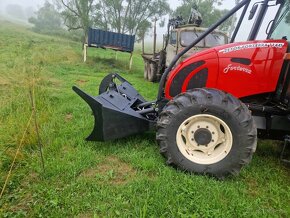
left=156, top=88, right=257, bottom=179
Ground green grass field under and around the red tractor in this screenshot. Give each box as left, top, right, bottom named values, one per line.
left=0, top=21, right=290, bottom=217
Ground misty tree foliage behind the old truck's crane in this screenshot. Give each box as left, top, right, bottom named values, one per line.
left=172, top=0, right=231, bottom=31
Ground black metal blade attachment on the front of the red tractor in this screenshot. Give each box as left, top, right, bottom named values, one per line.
left=73, top=74, right=156, bottom=141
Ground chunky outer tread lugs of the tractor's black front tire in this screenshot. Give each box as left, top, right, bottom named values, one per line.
left=157, top=88, right=257, bottom=179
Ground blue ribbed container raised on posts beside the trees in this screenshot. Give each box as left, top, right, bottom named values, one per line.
left=88, top=28, right=135, bottom=52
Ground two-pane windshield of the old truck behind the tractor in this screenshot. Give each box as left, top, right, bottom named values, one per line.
left=180, top=31, right=226, bottom=47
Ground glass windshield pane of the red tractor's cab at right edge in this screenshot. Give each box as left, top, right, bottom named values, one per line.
left=269, top=0, right=290, bottom=40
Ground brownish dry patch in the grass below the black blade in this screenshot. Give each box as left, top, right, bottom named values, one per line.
left=80, top=156, right=136, bottom=185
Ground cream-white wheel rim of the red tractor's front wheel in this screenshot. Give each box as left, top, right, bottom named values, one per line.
left=176, top=114, right=233, bottom=164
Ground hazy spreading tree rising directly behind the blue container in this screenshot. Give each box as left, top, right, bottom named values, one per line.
left=94, top=0, right=170, bottom=40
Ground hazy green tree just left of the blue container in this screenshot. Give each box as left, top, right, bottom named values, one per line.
left=58, top=0, right=94, bottom=40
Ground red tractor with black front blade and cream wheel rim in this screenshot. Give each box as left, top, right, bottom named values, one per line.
left=73, top=0, right=290, bottom=178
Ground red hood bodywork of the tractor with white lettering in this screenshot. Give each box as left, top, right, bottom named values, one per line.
left=165, top=40, right=288, bottom=99
